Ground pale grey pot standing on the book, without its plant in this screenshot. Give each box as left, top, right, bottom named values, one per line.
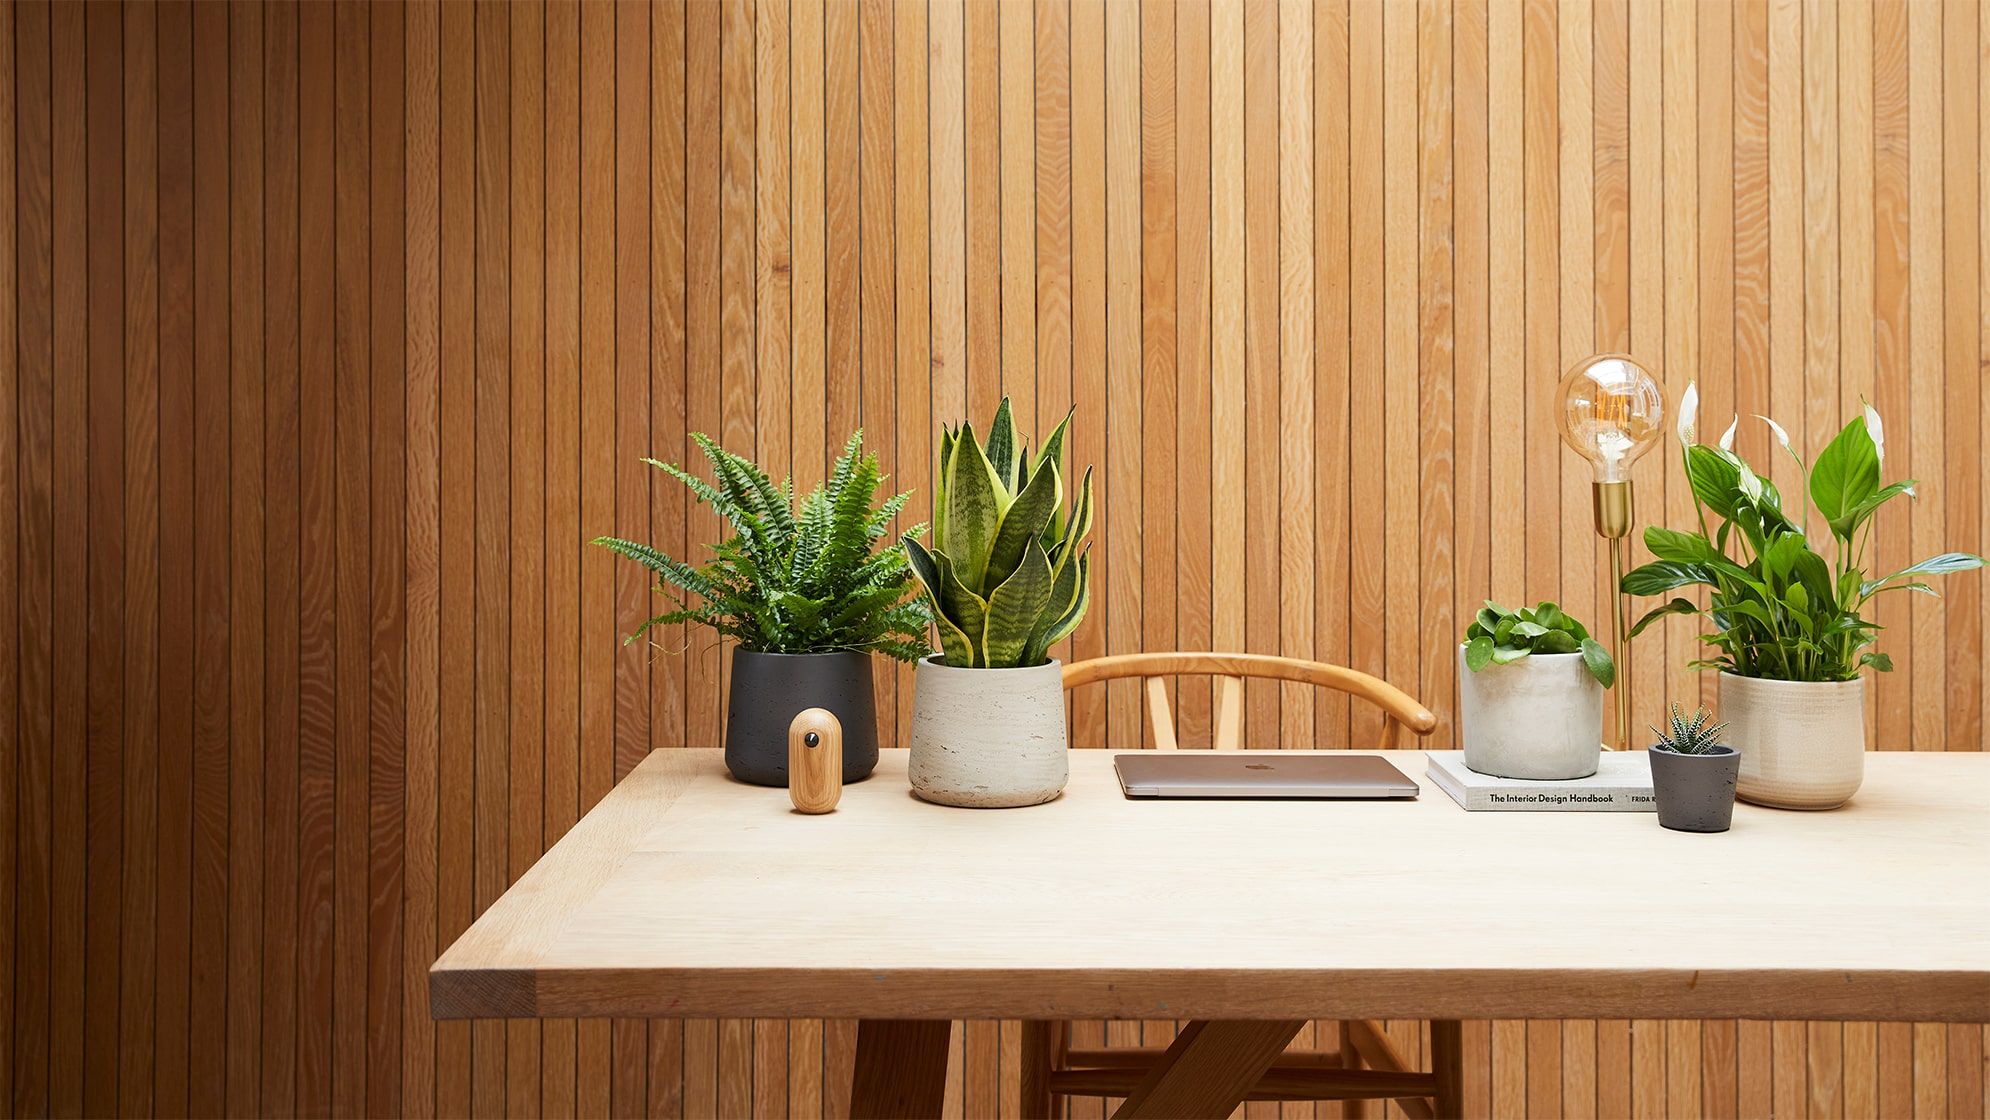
left=1459, top=645, right=1604, bottom=780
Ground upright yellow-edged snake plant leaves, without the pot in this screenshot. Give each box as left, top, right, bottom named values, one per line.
left=905, top=398, right=1093, bottom=668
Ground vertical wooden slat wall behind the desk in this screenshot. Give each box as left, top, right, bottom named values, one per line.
left=0, top=0, right=1990, bottom=1116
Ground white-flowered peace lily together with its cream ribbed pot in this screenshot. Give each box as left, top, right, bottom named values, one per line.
left=1624, top=388, right=1984, bottom=810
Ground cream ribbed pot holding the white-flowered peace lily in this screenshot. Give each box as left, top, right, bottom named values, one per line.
left=1721, top=672, right=1865, bottom=810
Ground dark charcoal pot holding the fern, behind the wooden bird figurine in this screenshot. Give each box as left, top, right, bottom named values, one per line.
left=726, top=649, right=878, bottom=786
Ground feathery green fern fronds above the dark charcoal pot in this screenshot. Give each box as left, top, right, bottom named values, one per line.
left=593, top=430, right=929, bottom=660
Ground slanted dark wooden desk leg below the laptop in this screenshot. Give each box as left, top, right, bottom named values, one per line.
left=1112, top=1019, right=1305, bottom=1120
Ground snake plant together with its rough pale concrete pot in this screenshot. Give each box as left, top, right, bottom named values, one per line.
left=905, top=398, right=1093, bottom=808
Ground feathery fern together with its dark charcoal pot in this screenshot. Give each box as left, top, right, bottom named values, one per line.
left=593, top=430, right=929, bottom=786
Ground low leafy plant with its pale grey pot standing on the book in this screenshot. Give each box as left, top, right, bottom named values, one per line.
left=1459, top=599, right=1616, bottom=780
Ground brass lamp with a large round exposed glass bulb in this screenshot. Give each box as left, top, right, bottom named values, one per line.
left=1554, top=354, right=1666, bottom=750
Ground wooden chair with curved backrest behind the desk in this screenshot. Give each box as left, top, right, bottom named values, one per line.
left=1023, top=653, right=1463, bottom=1120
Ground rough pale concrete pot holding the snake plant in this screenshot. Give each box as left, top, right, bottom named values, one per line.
left=909, top=656, right=1071, bottom=810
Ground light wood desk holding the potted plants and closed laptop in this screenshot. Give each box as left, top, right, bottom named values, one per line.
left=430, top=750, right=1990, bottom=1114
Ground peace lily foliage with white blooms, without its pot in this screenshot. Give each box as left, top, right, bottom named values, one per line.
left=1624, top=388, right=1984, bottom=680
